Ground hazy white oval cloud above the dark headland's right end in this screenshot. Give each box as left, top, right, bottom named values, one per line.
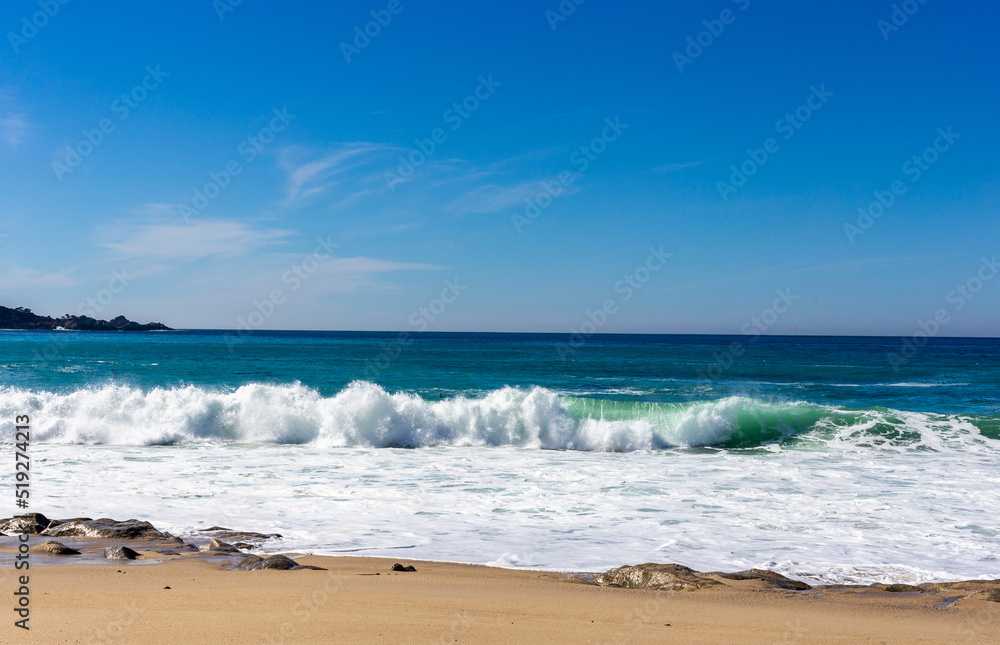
left=100, top=220, right=292, bottom=260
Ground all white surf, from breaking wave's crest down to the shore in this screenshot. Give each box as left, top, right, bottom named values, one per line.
left=0, top=382, right=1000, bottom=582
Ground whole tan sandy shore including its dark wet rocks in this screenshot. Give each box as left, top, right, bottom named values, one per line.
left=0, top=514, right=1000, bottom=645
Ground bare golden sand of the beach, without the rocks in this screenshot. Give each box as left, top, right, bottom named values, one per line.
left=0, top=556, right=1000, bottom=644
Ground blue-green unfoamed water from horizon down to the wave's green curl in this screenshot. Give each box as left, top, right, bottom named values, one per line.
left=0, top=331, right=1000, bottom=447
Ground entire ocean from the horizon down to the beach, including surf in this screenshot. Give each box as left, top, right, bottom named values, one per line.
left=0, top=331, right=1000, bottom=584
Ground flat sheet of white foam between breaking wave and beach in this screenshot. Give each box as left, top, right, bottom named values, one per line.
left=13, top=442, right=1000, bottom=584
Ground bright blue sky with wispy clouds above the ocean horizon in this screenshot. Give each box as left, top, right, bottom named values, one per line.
left=0, top=0, right=1000, bottom=336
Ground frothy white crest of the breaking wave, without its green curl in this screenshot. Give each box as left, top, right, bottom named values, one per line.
left=0, top=381, right=794, bottom=451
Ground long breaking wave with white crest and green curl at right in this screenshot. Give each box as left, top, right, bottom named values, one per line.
left=0, top=381, right=1000, bottom=452
